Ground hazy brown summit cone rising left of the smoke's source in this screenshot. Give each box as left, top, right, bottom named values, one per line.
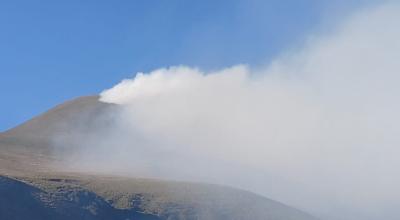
left=0, top=96, right=116, bottom=154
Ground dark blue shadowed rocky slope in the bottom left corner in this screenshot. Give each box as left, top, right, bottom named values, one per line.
left=0, top=176, right=160, bottom=220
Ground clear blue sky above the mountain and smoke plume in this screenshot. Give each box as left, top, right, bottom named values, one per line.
left=0, top=0, right=372, bottom=131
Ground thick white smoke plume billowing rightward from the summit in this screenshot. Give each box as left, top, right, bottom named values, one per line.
left=57, top=4, right=400, bottom=219
